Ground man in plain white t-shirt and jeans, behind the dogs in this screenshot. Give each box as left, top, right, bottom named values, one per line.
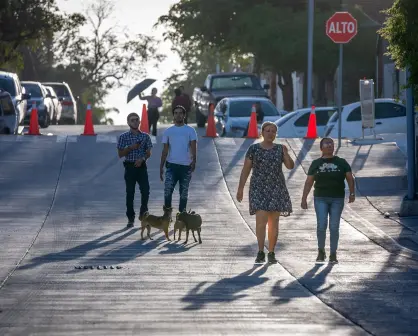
left=160, top=105, right=197, bottom=212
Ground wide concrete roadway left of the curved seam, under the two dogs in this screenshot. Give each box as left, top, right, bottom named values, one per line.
left=0, top=138, right=366, bottom=336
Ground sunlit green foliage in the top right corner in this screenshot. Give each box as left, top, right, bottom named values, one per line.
left=379, top=0, right=418, bottom=85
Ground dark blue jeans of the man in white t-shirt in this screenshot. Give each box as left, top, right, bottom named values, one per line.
left=164, top=162, right=192, bottom=212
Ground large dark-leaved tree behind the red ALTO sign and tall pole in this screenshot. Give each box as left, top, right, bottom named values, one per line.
left=158, top=0, right=375, bottom=110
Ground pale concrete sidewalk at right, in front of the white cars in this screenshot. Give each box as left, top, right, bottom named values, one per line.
left=286, top=139, right=418, bottom=252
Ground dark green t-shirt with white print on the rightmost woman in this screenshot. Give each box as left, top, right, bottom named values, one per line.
left=308, top=156, right=351, bottom=198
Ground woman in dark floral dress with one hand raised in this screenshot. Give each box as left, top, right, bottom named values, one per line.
left=237, top=121, right=295, bottom=263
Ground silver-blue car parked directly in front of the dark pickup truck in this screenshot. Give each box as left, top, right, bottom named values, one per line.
left=214, top=96, right=280, bottom=137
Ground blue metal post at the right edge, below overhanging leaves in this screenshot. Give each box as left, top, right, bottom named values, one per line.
left=406, top=68, right=416, bottom=200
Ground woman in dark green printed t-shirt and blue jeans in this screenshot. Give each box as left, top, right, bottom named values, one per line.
left=301, top=138, right=355, bottom=262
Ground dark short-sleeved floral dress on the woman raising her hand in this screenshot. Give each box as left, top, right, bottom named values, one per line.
left=245, top=143, right=292, bottom=217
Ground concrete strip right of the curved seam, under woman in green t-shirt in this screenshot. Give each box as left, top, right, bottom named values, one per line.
left=215, top=139, right=418, bottom=336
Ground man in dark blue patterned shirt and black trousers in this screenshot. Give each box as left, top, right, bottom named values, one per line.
left=117, top=113, right=152, bottom=227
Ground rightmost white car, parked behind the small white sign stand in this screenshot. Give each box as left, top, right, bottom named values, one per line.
left=324, top=98, right=412, bottom=139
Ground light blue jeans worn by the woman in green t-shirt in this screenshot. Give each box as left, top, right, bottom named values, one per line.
left=314, top=197, right=344, bottom=253
